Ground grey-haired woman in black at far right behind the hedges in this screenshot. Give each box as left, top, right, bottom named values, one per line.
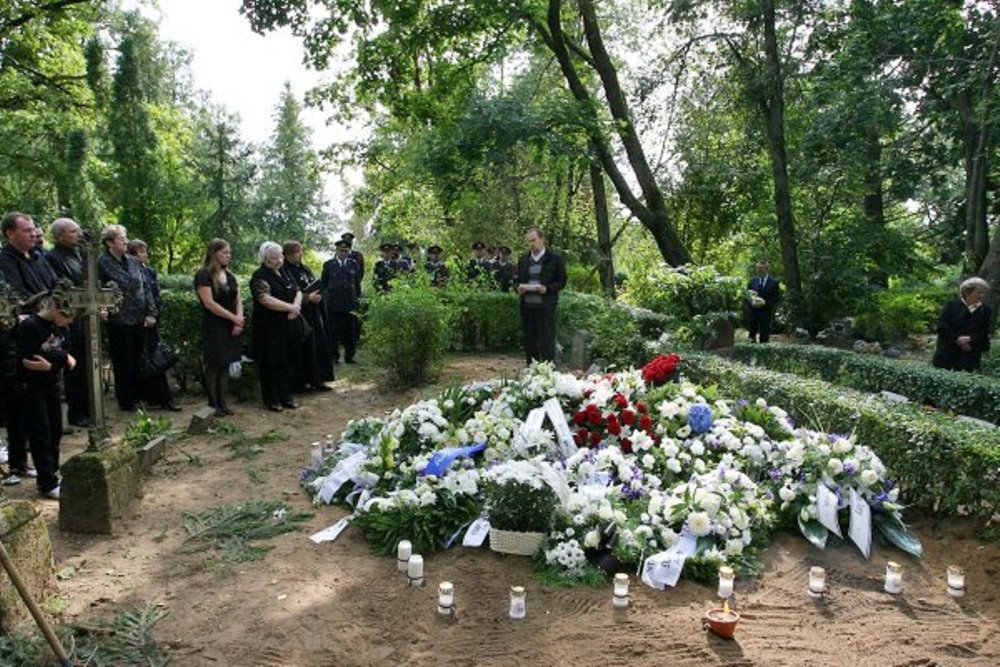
left=931, top=278, right=993, bottom=372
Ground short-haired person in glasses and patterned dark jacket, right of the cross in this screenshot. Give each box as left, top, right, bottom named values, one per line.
left=97, top=225, right=158, bottom=412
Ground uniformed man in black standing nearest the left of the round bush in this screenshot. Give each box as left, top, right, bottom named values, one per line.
left=320, top=239, right=360, bottom=364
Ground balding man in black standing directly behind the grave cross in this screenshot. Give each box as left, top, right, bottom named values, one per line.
left=45, top=218, right=90, bottom=428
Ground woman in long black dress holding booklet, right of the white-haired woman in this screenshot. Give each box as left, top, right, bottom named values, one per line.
left=281, top=241, right=333, bottom=391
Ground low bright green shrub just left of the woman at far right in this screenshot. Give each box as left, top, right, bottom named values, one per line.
left=854, top=287, right=954, bottom=341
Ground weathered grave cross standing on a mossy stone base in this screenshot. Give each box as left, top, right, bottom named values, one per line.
left=55, top=236, right=122, bottom=449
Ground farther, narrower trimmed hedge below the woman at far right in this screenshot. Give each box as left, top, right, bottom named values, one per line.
left=733, top=343, right=1000, bottom=423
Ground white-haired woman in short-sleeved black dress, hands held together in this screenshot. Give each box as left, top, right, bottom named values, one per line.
left=250, top=241, right=302, bottom=412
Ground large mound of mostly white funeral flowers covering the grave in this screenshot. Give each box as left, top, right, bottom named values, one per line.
left=303, top=355, right=921, bottom=581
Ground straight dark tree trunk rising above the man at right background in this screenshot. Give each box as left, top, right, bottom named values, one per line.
left=761, top=0, right=802, bottom=312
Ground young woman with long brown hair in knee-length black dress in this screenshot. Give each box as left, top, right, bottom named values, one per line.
left=194, top=239, right=246, bottom=415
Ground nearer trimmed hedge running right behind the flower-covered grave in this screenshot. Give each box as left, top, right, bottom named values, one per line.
left=681, top=353, right=1000, bottom=524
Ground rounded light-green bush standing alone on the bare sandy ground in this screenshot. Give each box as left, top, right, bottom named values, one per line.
left=364, top=281, right=451, bottom=387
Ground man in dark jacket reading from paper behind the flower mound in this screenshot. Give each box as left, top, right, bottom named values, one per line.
left=517, top=227, right=566, bottom=364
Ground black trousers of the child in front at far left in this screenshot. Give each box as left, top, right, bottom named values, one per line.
left=12, top=384, right=62, bottom=492
